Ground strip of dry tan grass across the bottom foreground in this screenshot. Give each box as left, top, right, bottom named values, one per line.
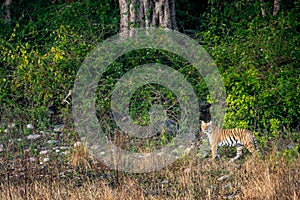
left=0, top=147, right=300, bottom=200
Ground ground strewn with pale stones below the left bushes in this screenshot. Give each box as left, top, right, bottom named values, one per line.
left=0, top=123, right=207, bottom=185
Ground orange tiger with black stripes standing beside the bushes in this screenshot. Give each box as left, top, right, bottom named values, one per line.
left=201, top=121, right=259, bottom=162
